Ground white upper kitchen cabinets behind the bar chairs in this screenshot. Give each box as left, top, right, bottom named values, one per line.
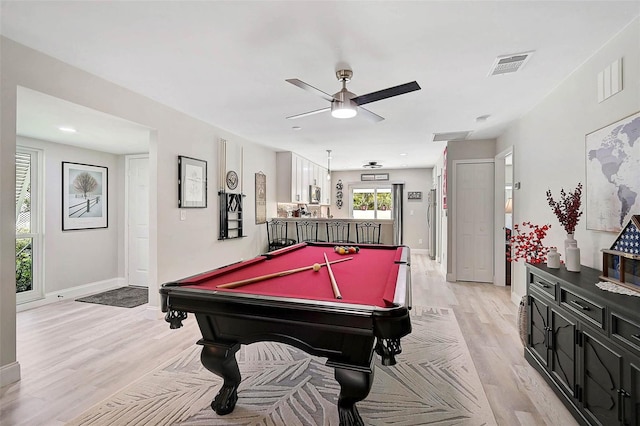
left=276, top=152, right=329, bottom=204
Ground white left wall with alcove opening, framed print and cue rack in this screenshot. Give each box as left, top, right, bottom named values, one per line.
left=0, top=37, right=276, bottom=384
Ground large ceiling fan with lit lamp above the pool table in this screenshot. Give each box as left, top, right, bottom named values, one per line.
left=287, top=69, right=420, bottom=122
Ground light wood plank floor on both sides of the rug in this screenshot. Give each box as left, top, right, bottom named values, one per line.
left=0, top=254, right=577, bottom=426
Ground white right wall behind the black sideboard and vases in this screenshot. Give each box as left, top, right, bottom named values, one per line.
left=497, top=19, right=640, bottom=300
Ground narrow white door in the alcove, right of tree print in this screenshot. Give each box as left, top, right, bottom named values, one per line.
left=127, top=156, right=149, bottom=287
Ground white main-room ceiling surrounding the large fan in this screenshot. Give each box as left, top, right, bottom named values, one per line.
left=0, top=1, right=640, bottom=170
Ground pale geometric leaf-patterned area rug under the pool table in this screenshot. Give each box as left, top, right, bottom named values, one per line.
left=69, top=306, right=496, bottom=426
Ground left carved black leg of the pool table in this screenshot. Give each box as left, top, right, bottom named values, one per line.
left=198, top=341, right=241, bottom=416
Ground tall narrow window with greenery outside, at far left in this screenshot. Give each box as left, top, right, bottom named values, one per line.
left=16, top=147, right=42, bottom=303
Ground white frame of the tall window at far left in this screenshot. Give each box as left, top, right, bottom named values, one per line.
left=16, top=145, right=44, bottom=305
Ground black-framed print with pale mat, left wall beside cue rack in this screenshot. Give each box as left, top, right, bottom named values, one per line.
left=178, top=155, right=207, bottom=209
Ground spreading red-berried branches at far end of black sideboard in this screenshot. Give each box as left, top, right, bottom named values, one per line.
left=507, top=222, right=551, bottom=264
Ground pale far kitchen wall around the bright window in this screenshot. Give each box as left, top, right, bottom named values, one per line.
left=331, top=169, right=433, bottom=250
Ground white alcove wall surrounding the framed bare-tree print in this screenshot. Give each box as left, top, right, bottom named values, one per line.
left=17, top=136, right=124, bottom=293
